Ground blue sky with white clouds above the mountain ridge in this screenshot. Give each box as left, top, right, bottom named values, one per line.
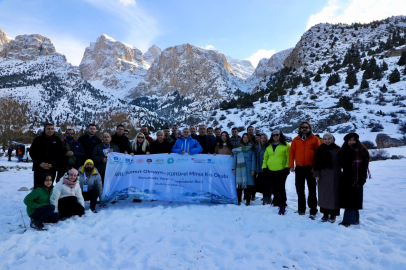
left=0, top=0, right=406, bottom=66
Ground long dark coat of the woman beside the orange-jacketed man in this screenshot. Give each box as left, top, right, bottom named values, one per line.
left=313, top=144, right=341, bottom=210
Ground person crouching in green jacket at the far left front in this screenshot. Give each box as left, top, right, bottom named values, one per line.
left=24, top=173, right=59, bottom=231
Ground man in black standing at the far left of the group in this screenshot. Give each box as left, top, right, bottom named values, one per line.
left=30, top=124, right=62, bottom=188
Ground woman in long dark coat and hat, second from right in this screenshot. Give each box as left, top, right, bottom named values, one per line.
left=313, top=133, right=341, bottom=223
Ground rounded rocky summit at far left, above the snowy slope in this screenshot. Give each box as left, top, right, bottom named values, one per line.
left=0, top=35, right=56, bottom=61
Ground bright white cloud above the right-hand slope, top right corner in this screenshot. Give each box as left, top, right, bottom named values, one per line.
left=306, top=0, right=406, bottom=29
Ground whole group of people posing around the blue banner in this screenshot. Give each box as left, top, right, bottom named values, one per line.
left=24, top=122, right=369, bottom=230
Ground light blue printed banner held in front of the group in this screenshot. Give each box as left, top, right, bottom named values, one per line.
left=103, top=152, right=237, bottom=204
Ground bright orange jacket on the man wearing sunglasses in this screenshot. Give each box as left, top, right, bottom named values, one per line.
left=289, top=134, right=321, bottom=168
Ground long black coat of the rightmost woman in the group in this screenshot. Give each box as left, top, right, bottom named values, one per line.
left=339, top=149, right=369, bottom=209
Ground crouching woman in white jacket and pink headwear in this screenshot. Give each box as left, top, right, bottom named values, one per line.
left=51, top=168, right=85, bottom=219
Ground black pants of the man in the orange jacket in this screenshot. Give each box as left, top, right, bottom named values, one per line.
left=295, top=166, right=317, bottom=215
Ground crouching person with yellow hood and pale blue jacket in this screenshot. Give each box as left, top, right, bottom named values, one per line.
left=79, top=159, right=103, bottom=213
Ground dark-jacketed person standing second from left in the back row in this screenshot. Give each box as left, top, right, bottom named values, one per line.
left=56, top=128, right=85, bottom=182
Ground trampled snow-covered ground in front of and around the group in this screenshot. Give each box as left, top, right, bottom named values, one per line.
left=0, top=150, right=406, bottom=270
